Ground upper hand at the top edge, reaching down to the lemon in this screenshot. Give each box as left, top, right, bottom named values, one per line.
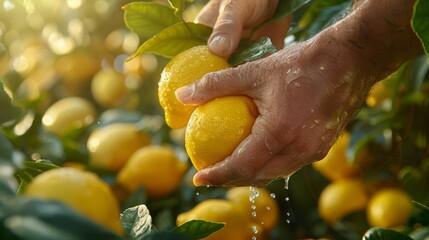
left=195, top=0, right=291, bottom=57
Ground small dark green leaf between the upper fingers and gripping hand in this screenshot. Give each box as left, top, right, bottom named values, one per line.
left=228, top=37, right=277, bottom=66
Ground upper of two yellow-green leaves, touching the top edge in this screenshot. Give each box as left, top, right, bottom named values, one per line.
left=123, top=2, right=180, bottom=38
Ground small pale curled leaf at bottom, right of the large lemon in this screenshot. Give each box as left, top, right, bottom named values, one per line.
left=121, top=204, right=153, bottom=239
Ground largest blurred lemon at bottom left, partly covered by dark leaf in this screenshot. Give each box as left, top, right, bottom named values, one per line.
left=24, top=168, right=122, bottom=234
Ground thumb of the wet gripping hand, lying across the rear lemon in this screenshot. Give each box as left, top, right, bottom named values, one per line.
left=175, top=63, right=254, bottom=105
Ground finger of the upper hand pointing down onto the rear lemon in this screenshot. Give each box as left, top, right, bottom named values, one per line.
left=208, top=1, right=247, bottom=57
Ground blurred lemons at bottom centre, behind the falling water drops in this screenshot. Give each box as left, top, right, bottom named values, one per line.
left=176, top=187, right=279, bottom=240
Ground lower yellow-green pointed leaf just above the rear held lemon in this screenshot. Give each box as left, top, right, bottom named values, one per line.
left=128, top=22, right=212, bottom=60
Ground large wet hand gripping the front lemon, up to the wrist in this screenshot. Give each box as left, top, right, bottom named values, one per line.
left=176, top=35, right=370, bottom=186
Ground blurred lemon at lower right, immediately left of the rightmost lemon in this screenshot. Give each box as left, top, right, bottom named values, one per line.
left=318, top=179, right=368, bottom=224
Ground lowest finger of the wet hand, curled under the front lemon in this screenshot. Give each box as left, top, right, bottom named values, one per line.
left=194, top=118, right=281, bottom=186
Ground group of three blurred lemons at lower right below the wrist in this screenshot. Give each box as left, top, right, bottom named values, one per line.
left=313, top=132, right=412, bottom=228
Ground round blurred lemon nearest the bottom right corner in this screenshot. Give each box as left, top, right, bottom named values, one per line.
left=367, top=188, right=413, bottom=228
